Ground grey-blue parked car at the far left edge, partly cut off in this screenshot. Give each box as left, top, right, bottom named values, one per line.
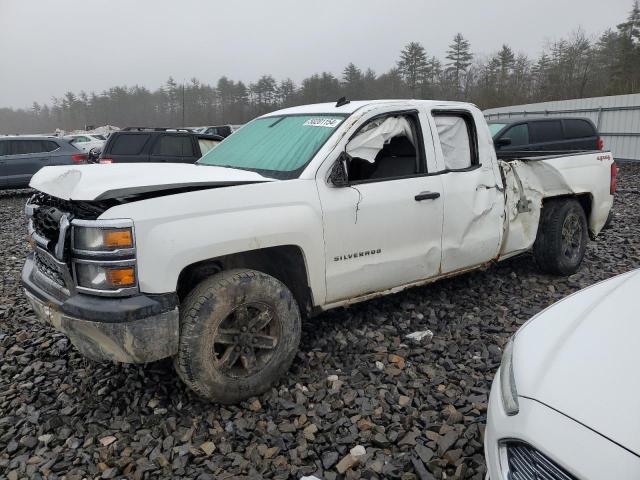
left=0, top=136, right=87, bottom=189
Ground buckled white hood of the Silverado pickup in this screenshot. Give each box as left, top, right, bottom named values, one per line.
left=29, top=163, right=275, bottom=201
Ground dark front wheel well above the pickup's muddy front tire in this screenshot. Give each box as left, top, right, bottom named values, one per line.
left=176, top=245, right=313, bottom=315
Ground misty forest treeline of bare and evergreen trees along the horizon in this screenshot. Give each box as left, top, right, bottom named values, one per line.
left=0, top=0, right=640, bottom=133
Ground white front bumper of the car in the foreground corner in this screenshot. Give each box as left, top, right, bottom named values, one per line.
left=484, top=374, right=640, bottom=480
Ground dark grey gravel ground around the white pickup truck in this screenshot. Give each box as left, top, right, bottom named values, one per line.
left=0, top=165, right=640, bottom=480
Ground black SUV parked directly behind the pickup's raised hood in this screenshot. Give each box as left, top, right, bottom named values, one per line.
left=99, top=127, right=223, bottom=163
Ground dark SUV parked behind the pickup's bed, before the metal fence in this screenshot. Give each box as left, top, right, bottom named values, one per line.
left=488, top=117, right=604, bottom=158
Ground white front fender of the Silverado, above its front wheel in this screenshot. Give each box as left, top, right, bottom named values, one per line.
left=100, top=180, right=326, bottom=303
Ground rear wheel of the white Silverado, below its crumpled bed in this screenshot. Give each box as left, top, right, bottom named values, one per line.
left=533, top=200, right=588, bottom=275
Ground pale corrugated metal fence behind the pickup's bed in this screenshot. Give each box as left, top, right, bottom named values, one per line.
left=484, top=94, right=640, bottom=161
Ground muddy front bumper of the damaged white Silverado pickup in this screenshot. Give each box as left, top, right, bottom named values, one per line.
left=22, top=254, right=179, bottom=363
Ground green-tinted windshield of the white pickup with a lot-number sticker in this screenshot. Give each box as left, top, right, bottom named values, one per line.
left=198, top=114, right=346, bottom=178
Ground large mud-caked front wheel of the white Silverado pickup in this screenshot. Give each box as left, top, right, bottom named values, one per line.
left=174, top=270, right=301, bottom=404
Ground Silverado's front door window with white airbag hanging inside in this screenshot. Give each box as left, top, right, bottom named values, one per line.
left=347, top=114, right=424, bottom=182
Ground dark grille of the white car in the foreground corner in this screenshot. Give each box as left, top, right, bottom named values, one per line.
left=507, top=443, right=577, bottom=480
